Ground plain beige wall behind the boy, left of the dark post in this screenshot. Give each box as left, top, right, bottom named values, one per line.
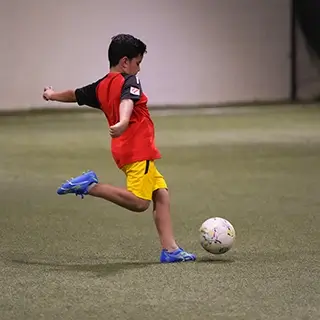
left=0, top=0, right=318, bottom=109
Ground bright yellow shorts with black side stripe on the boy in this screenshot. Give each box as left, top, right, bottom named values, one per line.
left=121, top=160, right=168, bottom=200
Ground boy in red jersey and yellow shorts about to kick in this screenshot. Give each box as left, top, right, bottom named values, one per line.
left=43, top=34, right=196, bottom=263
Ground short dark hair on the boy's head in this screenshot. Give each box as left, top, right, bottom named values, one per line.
left=108, top=34, right=147, bottom=67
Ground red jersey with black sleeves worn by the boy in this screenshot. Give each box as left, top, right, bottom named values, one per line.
left=75, top=73, right=161, bottom=168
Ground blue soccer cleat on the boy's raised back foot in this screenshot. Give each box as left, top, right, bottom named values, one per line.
left=57, top=171, right=98, bottom=198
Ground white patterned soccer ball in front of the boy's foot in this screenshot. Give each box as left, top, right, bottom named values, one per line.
left=199, top=217, right=236, bottom=254
